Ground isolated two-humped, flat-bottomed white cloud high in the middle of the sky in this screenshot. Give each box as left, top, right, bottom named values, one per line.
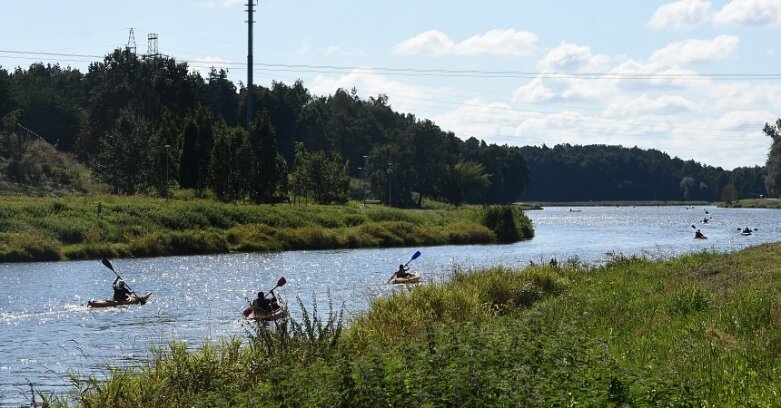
left=393, top=29, right=537, bottom=56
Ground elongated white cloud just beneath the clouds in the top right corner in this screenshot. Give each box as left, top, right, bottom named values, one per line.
left=651, top=35, right=740, bottom=64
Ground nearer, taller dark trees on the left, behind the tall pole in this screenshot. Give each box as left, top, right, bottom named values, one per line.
left=0, top=49, right=529, bottom=207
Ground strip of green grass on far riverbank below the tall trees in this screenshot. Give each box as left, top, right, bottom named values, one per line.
left=0, top=195, right=534, bottom=262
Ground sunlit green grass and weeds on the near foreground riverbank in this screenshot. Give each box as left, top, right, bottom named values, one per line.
left=54, top=243, right=781, bottom=408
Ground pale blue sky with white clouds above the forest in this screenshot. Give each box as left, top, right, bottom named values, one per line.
left=0, top=0, right=781, bottom=169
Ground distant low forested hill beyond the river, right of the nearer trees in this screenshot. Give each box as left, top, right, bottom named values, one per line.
left=521, top=144, right=767, bottom=201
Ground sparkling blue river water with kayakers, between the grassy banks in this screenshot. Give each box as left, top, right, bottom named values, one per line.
left=0, top=206, right=781, bottom=407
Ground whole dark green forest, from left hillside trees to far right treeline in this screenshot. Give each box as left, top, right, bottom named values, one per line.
left=0, top=49, right=778, bottom=207
